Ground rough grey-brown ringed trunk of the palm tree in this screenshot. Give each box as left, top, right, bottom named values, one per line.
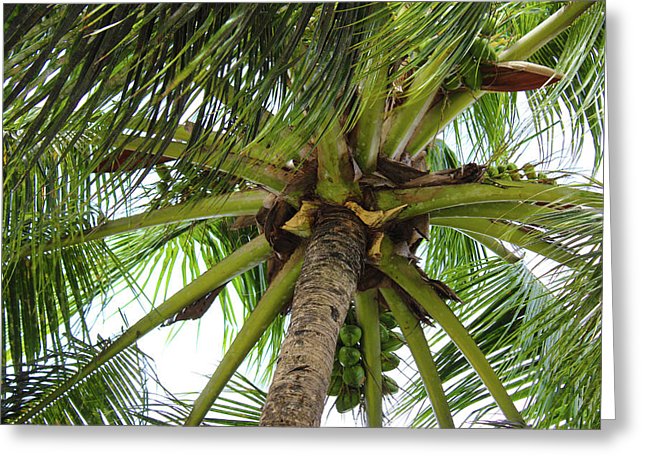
left=260, top=207, right=366, bottom=427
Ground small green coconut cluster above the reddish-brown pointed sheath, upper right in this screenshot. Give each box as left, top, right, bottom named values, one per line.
left=442, top=18, right=498, bottom=91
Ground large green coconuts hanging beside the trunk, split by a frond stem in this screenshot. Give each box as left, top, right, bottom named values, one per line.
left=328, top=312, right=404, bottom=413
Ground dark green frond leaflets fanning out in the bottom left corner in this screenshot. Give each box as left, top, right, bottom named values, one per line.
left=1, top=338, right=151, bottom=425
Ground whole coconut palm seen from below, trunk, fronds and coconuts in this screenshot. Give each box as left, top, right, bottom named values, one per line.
left=2, top=2, right=605, bottom=428
